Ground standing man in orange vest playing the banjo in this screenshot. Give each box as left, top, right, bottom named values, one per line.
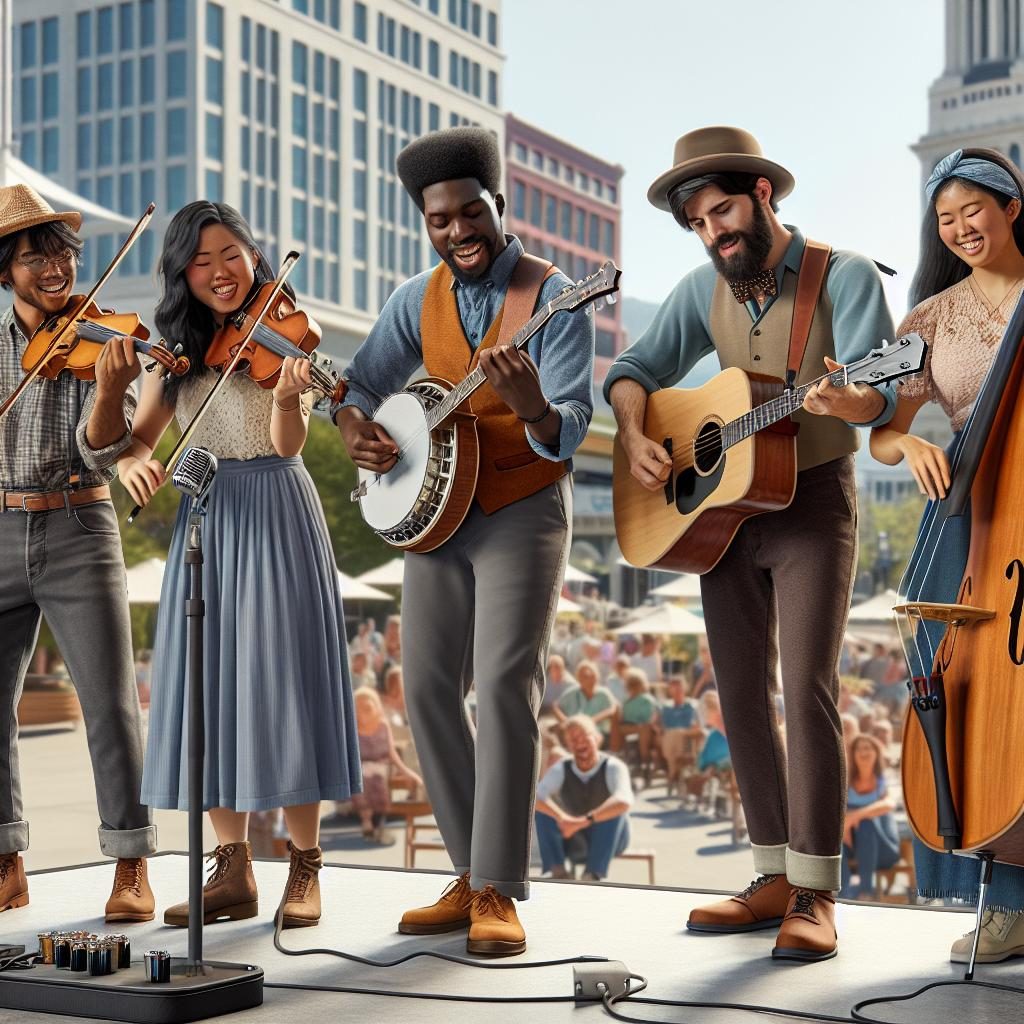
left=333, top=128, right=594, bottom=956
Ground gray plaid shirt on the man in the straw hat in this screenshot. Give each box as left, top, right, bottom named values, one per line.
left=0, top=306, right=135, bottom=490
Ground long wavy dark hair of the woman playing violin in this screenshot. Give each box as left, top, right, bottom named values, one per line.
left=154, top=200, right=295, bottom=406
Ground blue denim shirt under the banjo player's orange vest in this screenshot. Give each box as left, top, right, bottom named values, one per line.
left=331, top=234, right=594, bottom=462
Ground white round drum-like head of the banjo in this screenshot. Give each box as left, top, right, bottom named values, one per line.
left=359, top=391, right=430, bottom=530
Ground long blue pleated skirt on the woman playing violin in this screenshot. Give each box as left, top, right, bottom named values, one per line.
left=142, top=456, right=361, bottom=811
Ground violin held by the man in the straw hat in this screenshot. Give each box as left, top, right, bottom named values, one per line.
left=22, top=295, right=188, bottom=381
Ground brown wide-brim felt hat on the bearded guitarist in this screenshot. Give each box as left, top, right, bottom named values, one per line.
left=647, top=125, right=797, bottom=211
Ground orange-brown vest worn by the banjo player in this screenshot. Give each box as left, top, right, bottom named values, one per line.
left=420, top=254, right=568, bottom=515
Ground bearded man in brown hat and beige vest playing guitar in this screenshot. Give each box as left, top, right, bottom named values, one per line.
left=604, top=127, right=894, bottom=961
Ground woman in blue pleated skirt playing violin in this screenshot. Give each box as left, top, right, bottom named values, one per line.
left=119, top=202, right=360, bottom=927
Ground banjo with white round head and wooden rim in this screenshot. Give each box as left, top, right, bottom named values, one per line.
left=350, top=260, right=622, bottom=552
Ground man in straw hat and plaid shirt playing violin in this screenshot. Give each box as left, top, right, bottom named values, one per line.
left=0, top=185, right=157, bottom=922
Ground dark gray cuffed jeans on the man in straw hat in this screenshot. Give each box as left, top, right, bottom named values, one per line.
left=0, top=502, right=157, bottom=857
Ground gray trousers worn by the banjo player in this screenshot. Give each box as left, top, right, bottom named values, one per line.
left=401, top=476, right=572, bottom=900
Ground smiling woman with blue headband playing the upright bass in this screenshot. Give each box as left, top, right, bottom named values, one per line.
left=871, top=148, right=1024, bottom=964
